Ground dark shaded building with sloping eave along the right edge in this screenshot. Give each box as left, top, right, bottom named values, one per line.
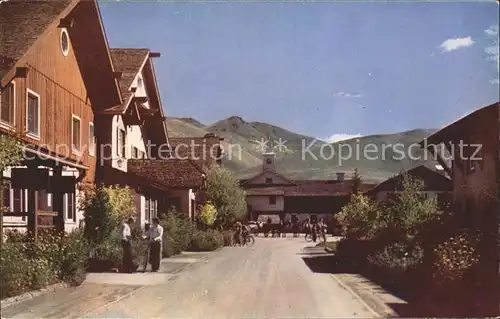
left=421, top=103, right=500, bottom=316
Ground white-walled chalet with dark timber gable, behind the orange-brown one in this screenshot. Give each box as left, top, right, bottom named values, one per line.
left=96, top=48, right=174, bottom=225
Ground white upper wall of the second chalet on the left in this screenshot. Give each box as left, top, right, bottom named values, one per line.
left=111, top=115, right=148, bottom=172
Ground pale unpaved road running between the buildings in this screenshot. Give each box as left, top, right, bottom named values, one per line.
left=1, top=238, right=375, bottom=318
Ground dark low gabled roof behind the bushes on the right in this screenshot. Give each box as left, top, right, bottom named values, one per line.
left=365, top=165, right=453, bottom=195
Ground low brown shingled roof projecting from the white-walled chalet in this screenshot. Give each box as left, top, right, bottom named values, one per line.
left=127, top=159, right=206, bottom=188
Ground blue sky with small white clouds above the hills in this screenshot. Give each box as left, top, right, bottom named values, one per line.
left=100, top=1, right=499, bottom=142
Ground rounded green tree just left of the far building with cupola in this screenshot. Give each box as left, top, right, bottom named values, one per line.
left=206, top=167, right=247, bottom=227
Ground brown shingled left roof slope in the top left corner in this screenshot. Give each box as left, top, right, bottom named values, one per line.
left=0, top=0, right=78, bottom=78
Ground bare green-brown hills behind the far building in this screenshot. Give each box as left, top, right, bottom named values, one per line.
left=167, top=116, right=436, bottom=181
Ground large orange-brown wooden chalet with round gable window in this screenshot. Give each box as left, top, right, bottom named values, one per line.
left=0, top=0, right=121, bottom=230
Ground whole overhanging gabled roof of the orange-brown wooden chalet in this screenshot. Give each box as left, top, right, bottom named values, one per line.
left=0, top=0, right=122, bottom=107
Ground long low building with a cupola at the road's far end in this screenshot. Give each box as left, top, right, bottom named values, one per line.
left=241, top=153, right=373, bottom=223
